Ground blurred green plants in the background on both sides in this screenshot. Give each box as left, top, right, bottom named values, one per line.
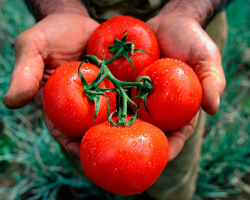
left=0, top=0, right=250, bottom=200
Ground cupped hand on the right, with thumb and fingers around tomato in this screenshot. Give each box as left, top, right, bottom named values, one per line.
left=147, top=12, right=226, bottom=160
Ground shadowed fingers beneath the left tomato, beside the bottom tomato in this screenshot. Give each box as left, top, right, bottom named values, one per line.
left=43, top=110, right=81, bottom=159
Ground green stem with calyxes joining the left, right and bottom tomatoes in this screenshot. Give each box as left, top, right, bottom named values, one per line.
left=78, top=55, right=152, bottom=127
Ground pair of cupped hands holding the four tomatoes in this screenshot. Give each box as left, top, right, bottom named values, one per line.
left=3, top=7, right=225, bottom=161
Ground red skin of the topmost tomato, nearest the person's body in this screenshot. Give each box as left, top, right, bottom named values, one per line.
left=87, top=16, right=159, bottom=81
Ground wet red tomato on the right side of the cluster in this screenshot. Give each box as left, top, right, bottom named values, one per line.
left=132, top=58, right=202, bottom=131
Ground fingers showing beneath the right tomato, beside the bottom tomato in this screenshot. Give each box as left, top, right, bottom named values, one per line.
left=166, top=113, right=199, bottom=161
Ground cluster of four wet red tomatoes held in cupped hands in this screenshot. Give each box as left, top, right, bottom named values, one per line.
left=43, top=16, right=202, bottom=195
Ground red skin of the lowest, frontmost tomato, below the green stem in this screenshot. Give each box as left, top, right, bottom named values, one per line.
left=80, top=119, right=169, bottom=195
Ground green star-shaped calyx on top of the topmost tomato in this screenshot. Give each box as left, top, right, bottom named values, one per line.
left=105, top=30, right=150, bottom=73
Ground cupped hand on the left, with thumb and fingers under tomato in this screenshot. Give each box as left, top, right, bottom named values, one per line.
left=3, top=12, right=99, bottom=157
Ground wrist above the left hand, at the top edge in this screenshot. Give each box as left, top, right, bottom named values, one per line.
left=25, top=0, right=89, bottom=21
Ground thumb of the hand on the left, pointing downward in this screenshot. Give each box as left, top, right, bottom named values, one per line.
left=3, top=29, right=47, bottom=109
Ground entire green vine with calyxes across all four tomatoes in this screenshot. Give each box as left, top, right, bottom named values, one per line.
left=78, top=32, right=152, bottom=126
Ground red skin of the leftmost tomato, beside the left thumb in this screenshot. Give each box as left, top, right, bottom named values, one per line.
left=43, top=62, right=116, bottom=137
